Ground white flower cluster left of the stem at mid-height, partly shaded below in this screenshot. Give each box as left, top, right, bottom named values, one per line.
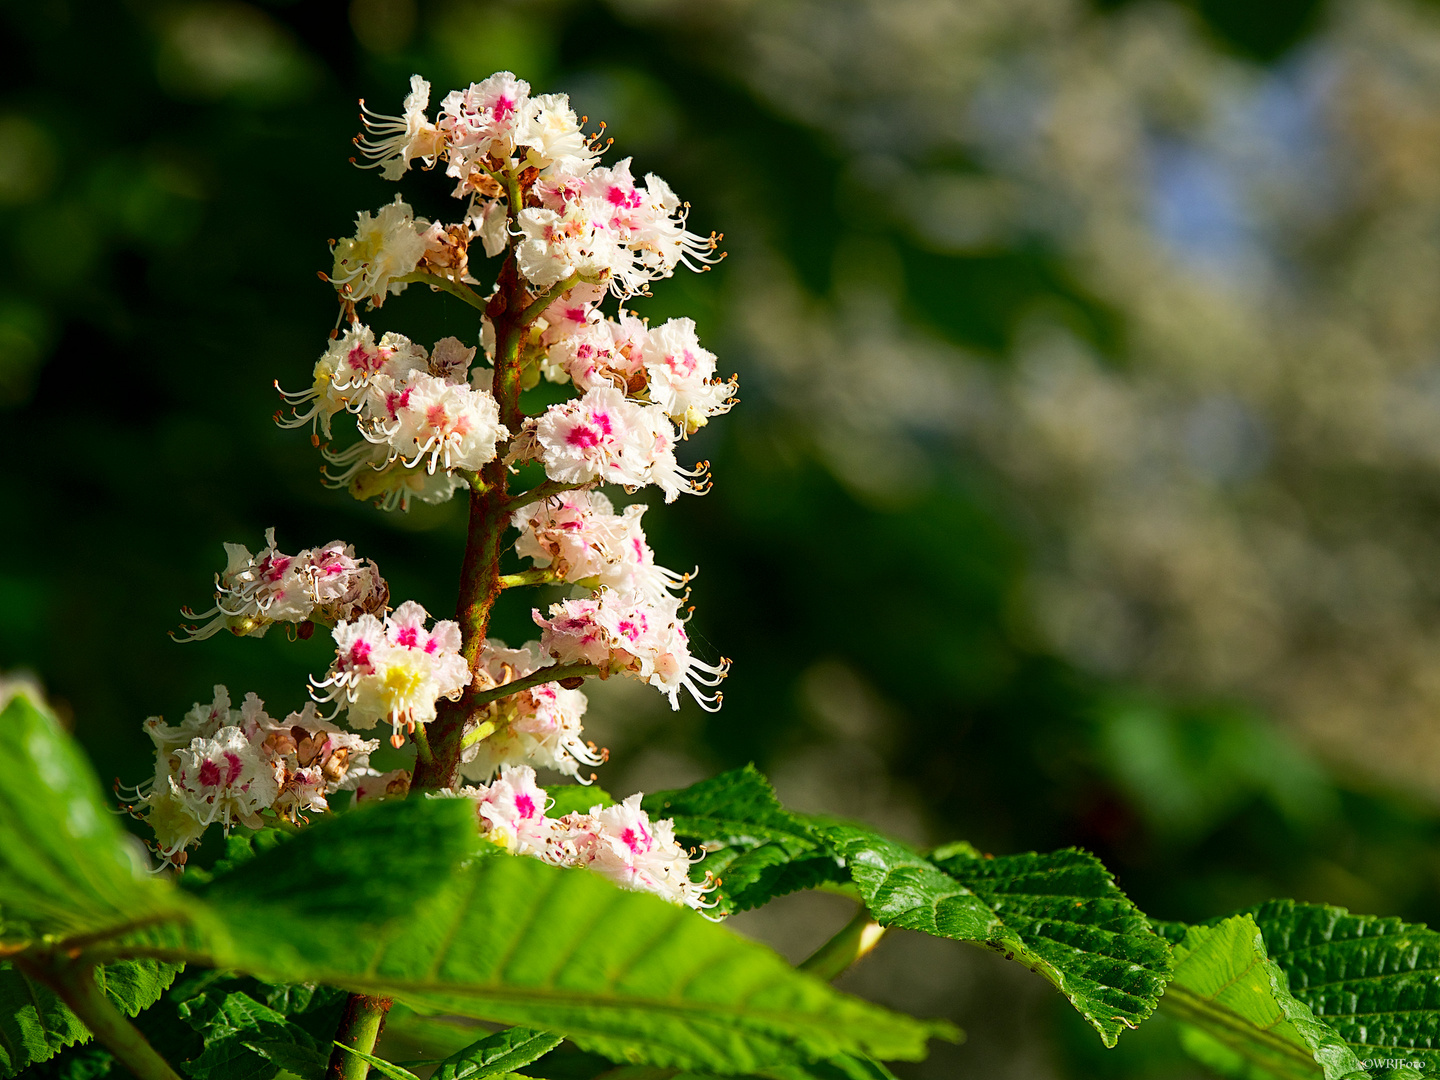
left=281, top=323, right=510, bottom=510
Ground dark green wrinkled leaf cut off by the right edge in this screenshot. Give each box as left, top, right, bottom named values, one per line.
left=1248, top=900, right=1440, bottom=1076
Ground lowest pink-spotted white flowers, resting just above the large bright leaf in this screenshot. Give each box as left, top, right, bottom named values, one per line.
left=455, top=765, right=714, bottom=909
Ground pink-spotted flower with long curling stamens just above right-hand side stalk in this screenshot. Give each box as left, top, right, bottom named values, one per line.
left=531, top=589, right=730, bottom=711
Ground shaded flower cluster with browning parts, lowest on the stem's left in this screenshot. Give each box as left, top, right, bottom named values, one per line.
left=128, top=685, right=380, bottom=865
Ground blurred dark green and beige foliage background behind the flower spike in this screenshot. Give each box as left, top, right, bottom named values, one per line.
left=8, top=0, right=1440, bottom=1077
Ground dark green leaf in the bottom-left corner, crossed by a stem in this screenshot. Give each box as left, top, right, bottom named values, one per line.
left=0, top=960, right=180, bottom=1077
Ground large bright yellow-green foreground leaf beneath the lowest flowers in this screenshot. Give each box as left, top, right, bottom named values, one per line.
left=224, top=855, right=943, bottom=1071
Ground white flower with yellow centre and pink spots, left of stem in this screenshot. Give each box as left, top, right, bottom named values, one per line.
left=314, top=600, right=472, bottom=749
